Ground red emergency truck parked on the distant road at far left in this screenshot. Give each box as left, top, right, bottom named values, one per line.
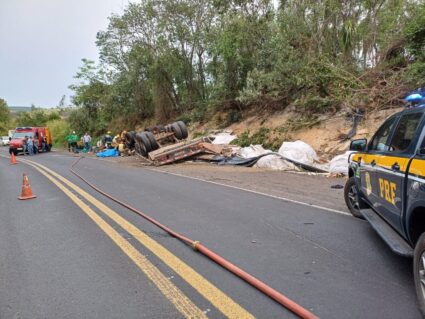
left=9, top=127, right=52, bottom=155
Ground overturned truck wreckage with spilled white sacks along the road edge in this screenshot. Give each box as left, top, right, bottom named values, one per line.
left=114, top=121, right=350, bottom=174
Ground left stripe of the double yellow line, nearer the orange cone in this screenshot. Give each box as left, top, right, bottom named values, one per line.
left=24, top=163, right=208, bottom=318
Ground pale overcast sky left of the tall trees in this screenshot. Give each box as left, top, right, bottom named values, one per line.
left=0, top=0, right=128, bottom=107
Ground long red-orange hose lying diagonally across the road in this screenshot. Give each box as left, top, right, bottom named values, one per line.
left=70, top=156, right=318, bottom=319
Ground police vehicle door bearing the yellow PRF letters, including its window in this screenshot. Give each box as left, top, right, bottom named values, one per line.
left=374, top=112, right=423, bottom=232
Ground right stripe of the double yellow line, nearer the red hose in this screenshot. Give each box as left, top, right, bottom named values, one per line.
left=25, top=160, right=254, bottom=319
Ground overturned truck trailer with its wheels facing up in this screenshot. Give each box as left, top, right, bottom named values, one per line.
left=126, top=121, right=220, bottom=166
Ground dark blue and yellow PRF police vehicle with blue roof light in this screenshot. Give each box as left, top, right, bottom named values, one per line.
left=344, top=92, right=425, bottom=317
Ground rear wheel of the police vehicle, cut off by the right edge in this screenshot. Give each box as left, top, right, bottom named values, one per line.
left=413, top=233, right=425, bottom=318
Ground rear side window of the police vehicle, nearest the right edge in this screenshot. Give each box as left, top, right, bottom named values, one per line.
left=389, top=113, right=422, bottom=152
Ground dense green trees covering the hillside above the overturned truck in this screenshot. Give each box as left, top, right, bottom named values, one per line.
left=0, top=0, right=425, bottom=148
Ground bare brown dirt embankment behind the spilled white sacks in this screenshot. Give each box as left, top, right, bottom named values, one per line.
left=190, top=107, right=402, bottom=161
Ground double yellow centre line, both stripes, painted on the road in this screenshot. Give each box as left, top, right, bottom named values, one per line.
left=17, top=159, right=254, bottom=319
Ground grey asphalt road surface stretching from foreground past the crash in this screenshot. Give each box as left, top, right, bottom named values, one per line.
left=0, top=149, right=420, bottom=319
